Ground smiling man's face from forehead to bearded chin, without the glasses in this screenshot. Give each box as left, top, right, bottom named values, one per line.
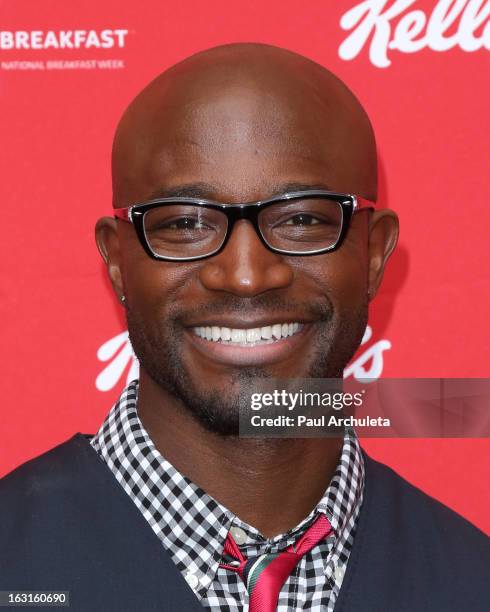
left=102, top=59, right=390, bottom=435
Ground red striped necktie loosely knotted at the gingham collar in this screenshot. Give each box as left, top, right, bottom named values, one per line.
left=220, top=514, right=332, bottom=612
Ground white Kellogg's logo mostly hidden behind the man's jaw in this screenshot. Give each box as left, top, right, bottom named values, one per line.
left=95, top=325, right=391, bottom=391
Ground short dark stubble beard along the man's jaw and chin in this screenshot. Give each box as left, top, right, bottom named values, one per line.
left=126, top=299, right=368, bottom=437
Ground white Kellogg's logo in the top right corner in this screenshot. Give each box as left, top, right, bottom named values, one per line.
left=339, top=0, right=490, bottom=68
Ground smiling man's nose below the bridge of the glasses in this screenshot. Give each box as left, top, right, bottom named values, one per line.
left=199, top=219, right=293, bottom=297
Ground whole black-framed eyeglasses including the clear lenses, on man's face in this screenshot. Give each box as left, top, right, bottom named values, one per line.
left=114, top=190, right=374, bottom=261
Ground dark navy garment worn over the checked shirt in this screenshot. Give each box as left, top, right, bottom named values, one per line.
left=0, top=434, right=490, bottom=612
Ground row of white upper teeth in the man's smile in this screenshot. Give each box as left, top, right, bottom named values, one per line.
left=193, top=323, right=302, bottom=345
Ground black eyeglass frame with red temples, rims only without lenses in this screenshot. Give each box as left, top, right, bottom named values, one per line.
left=114, top=189, right=375, bottom=262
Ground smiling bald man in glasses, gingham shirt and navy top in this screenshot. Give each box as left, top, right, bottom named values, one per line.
left=0, top=44, right=489, bottom=612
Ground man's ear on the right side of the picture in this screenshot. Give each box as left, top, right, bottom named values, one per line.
left=368, top=210, right=399, bottom=300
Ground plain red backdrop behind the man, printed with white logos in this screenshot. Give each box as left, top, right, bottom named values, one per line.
left=0, top=0, right=490, bottom=531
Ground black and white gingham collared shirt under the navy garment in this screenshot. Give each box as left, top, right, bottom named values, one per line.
left=91, top=381, right=364, bottom=612
